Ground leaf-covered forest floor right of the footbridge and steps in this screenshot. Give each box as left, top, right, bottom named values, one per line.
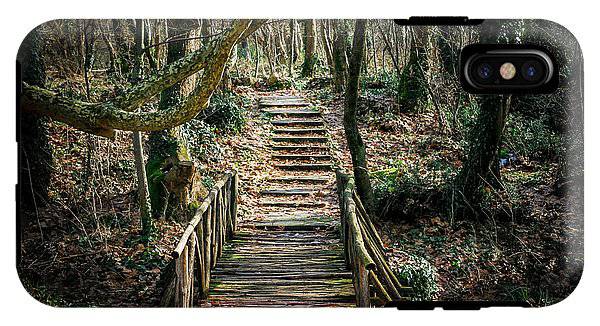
left=312, top=87, right=583, bottom=306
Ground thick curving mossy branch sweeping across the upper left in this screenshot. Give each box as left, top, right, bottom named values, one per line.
left=20, top=20, right=265, bottom=138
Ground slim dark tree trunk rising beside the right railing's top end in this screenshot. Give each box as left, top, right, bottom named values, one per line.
left=344, top=20, right=374, bottom=215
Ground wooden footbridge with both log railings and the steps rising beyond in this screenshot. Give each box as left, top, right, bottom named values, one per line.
left=163, top=96, right=407, bottom=307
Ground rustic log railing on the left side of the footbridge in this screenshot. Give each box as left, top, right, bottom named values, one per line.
left=161, top=171, right=239, bottom=307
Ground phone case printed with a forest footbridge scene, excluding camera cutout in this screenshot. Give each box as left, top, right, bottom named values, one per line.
left=17, top=17, right=583, bottom=309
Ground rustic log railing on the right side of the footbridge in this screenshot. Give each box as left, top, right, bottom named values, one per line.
left=336, top=170, right=410, bottom=307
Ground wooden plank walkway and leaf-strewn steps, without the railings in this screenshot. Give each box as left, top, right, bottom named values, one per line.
left=204, top=96, right=355, bottom=307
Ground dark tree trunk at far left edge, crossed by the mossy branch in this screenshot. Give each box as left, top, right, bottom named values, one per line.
left=17, top=28, right=53, bottom=211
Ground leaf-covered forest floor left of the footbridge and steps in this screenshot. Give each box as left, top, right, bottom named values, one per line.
left=18, top=87, right=270, bottom=307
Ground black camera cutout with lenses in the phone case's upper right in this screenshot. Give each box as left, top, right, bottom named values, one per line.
left=460, top=44, right=558, bottom=94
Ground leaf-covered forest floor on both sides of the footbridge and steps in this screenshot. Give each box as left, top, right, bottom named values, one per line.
left=19, top=83, right=583, bottom=306
